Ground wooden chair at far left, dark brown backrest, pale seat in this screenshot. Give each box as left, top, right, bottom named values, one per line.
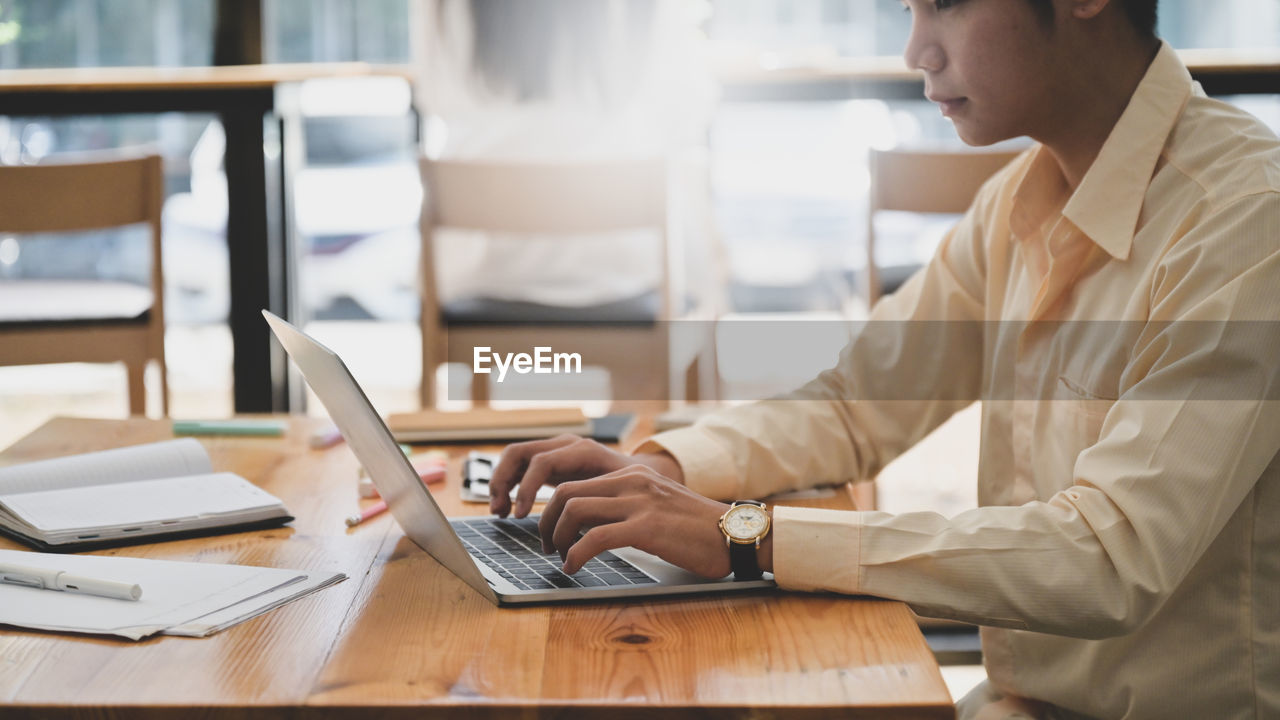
left=0, top=154, right=169, bottom=415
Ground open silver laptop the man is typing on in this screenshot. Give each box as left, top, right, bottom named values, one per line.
left=262, top=310, right=773, bottom=606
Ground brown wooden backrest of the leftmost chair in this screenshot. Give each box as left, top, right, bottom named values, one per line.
left=0, top=154, right=164, bottom=232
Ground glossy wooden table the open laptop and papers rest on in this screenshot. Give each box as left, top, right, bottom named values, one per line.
left=0, top=418, right=954, bottom=720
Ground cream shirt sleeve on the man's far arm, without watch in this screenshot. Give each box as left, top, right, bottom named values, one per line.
left=636, top=163, right=1016, bottom=500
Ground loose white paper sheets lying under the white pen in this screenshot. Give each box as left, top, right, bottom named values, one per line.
left=0, top=550, right=347, bottom=641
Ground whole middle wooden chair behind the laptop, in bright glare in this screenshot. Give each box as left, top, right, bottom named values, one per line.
left=420, top=158, right=710, bottom=407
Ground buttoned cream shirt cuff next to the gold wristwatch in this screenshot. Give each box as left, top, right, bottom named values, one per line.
left=773, top=506, right=863, bottom=593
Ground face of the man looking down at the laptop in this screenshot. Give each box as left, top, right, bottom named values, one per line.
left=902, top=0, right=1070, bottom=145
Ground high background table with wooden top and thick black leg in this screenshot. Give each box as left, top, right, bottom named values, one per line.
left=0, top=63, right=411, bottom=413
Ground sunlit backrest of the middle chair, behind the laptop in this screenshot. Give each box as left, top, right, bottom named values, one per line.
left=421, top=158, right=667, bottom=234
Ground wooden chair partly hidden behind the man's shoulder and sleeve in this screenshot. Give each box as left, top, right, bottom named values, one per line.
left=865, top=150, right=1021, bottom=307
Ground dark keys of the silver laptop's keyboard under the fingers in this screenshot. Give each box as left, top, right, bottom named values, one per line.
left=449, top=516, right=658, bottom=589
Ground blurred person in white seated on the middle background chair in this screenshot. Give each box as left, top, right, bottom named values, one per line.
left=413, top=0, right=717, bottom=307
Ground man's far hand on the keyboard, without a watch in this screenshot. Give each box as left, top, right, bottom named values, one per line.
left=489, top=434, right=685, bottom=518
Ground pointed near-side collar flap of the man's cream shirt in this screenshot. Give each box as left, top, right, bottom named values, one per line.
left=1059, top=42, right=1194, bottom=260
